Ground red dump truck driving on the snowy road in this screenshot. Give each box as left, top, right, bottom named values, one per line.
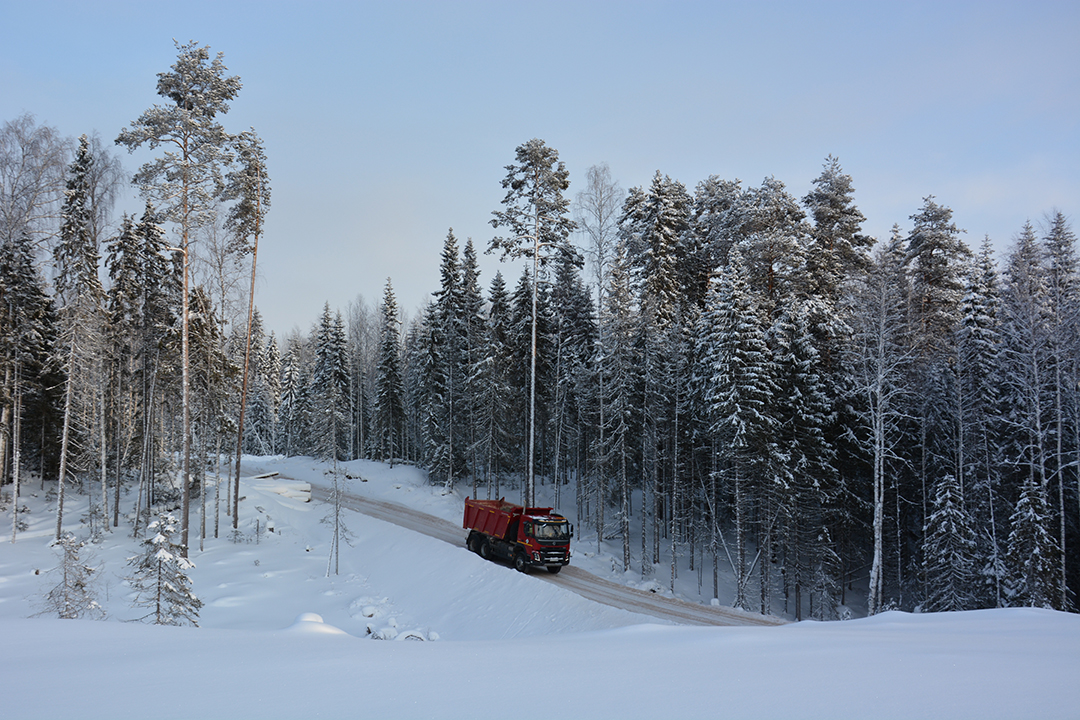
left=462, top=498, right=573, bottom=573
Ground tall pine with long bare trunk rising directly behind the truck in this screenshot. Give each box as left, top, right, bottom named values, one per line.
left=488, top=138, right=577, bottom=505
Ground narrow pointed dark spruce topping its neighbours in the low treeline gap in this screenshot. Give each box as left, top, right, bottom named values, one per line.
left=372, top=277, right=405, bottom=466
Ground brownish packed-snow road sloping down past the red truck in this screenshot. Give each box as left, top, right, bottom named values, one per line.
left=311, top=486, right=784, bottom=626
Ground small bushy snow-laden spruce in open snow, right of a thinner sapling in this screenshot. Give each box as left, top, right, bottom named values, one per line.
left=127, top=513, right=202, bottom=627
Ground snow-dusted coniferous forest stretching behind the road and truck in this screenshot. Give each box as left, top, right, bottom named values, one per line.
left=0, top=43, right=1080, bottom=620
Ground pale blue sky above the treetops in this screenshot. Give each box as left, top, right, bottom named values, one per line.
left=0, top=0, right=1080, bottom=335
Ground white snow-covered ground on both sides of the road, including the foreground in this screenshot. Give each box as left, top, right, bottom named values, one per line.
left=0, top=458, right=1080, bottom=718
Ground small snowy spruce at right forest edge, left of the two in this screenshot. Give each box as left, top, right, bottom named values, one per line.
left=922, top=475, right=976, bottom=612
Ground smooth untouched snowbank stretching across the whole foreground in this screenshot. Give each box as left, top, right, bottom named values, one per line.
left=0, top=610, right=1080, bottom=720
